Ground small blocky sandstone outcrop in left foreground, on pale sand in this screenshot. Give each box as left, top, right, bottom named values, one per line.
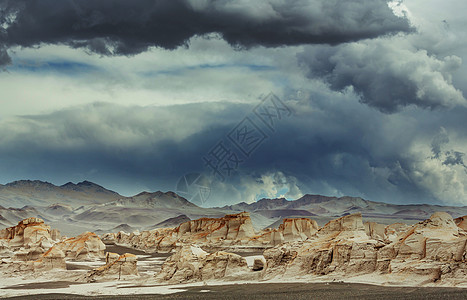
left=85, top=252, right=139, bottom=281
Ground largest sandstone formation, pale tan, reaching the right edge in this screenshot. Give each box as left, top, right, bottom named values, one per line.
left=264, top=213, right=467, bottom=285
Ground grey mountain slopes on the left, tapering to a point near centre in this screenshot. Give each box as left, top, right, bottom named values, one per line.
left=0, top=180, right=226, bottom=235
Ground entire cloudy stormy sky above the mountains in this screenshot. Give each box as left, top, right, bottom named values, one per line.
left=0, top=0, right=467, bottom=206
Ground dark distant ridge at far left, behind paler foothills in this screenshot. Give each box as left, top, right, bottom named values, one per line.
left=0, top=180, right=123, bottom=208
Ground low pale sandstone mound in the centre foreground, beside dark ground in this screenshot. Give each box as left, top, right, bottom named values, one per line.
left=156, top=245, right=258, bottom=283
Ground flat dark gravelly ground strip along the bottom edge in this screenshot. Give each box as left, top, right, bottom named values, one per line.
left=0, top=283, right=467, bottom=300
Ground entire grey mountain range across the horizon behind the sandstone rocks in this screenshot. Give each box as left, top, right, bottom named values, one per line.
left=0, top=180, right=467, bottom=235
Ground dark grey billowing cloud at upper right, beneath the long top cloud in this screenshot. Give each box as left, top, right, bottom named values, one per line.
left=299, top=39, right=466, bottom=113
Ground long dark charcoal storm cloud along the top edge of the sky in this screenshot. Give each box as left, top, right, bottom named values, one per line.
left=0, top=0, right=412, bottom=63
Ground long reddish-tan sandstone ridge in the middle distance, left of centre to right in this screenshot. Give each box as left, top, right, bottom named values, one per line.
left=102, top=212, right=318, bottom=252
